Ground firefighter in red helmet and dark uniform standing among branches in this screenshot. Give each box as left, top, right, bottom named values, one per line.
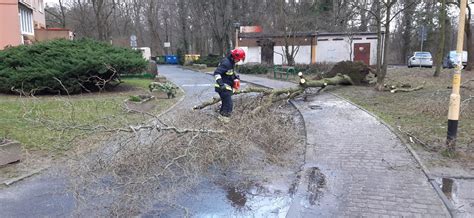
left=214, top=48, right=245, bottom=122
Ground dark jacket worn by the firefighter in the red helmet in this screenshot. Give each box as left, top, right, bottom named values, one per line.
left=214, top=55, right=238, bottom=92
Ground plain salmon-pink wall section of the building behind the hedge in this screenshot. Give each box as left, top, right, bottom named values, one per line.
left=0, top=0, right=22, bottom=49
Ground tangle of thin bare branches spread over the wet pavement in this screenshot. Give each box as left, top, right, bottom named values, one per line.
left=67, top=97, right=303, bottom=216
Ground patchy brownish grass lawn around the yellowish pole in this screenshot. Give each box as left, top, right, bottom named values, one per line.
left=332, top=67, right=474, bottom=169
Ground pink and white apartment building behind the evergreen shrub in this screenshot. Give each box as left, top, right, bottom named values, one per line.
left=0, top=0, right=46, bottom=49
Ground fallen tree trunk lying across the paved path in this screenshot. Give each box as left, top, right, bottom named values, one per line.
left=193, top=72, right=353, bottom=110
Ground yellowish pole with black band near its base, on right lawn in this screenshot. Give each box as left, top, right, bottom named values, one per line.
left=446, top=0, right=466, bottom=152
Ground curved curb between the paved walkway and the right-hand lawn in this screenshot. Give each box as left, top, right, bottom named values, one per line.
left=328, top=92, right=456, bottom=217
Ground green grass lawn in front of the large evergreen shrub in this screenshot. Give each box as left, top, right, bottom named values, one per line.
left=0, top=79, right=182, bottom=151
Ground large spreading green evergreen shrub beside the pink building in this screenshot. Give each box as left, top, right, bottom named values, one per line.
left=0, top=39, right=147, bottom=94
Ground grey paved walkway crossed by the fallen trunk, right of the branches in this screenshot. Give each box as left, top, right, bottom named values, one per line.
left=240, top=75, right=450, bottom=217
